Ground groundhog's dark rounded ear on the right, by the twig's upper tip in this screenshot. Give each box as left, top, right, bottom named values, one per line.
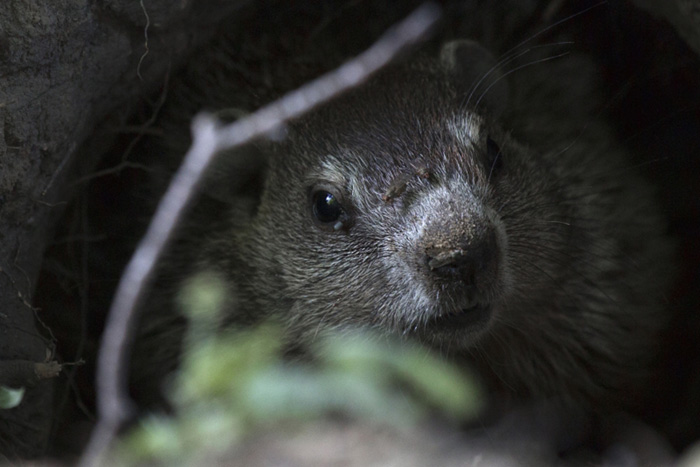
left=440, top=39, right=509, bottom=117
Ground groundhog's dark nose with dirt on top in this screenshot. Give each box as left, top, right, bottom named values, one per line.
left=425, top=229, right=498, bottom=287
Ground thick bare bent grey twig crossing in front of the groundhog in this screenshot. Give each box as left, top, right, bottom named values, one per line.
left=81, top=5, right=439, bottom=466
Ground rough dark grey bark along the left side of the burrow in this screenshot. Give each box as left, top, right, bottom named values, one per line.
left=0, top=0, right=250, bottom=457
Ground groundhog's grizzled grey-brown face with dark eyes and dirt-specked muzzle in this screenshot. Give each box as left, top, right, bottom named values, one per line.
left=238, top=45, right=572, bottom=348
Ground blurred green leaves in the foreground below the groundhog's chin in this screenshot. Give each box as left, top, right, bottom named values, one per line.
left=119, top=276, right=480, bottom=465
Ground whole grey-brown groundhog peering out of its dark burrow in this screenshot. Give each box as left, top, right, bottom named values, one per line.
left=132, top=5, right=672, bottom=414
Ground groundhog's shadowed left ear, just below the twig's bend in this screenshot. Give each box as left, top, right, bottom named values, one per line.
left=201, top=145, right=267, bottom=203
